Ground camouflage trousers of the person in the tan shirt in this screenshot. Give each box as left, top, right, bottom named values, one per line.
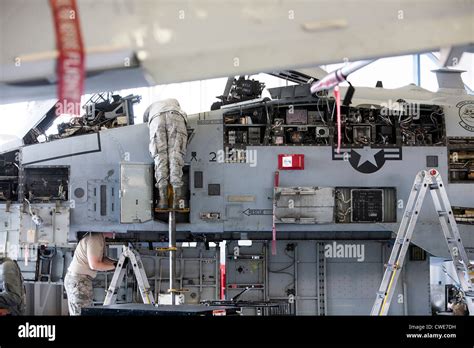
left=64, top=272, right=93, bottom=315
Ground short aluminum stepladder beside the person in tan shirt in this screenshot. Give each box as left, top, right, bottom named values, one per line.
left=104, top=244, right=155, bottom=306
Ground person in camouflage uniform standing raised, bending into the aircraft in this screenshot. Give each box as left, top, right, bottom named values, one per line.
left=144, top=99, right=188, bottom=209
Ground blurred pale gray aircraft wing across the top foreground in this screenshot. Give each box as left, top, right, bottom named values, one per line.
left=0, top=0, right=474, bottom=104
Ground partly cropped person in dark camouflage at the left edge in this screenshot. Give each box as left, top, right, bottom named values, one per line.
left=0, top=256, right=26, bottom=315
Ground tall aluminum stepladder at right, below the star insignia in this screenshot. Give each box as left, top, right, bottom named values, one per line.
left=370, top=169, right=474, bottom=315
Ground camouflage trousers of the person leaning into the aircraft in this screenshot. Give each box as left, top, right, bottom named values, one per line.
left=149, top=111, right=188, bottom=187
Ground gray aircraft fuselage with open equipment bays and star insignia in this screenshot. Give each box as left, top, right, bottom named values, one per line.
left=0, top=65, right=474, bottom=313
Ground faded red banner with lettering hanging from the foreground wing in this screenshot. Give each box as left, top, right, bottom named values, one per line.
left=49, top=0, right=85, bottom=116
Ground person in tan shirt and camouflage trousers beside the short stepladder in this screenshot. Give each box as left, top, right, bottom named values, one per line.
left=64, top=233, right=117, bottom=315
